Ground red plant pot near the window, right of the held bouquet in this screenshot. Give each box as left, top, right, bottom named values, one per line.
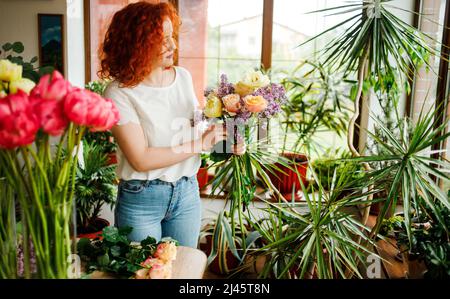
left=268, top=153, right=308, bottom=201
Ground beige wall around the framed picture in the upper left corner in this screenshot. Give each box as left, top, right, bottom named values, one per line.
left=0, top=0, right=67, bottom=78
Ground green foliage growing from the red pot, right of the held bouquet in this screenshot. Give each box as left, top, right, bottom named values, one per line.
left=282, top=61, right=351, bottom=153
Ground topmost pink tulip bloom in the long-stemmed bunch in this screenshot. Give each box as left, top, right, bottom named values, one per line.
left=31, top=71, right=73, bottom=101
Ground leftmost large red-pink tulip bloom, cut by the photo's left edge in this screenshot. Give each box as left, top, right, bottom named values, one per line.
left=0, top=90, right=39, bottom=149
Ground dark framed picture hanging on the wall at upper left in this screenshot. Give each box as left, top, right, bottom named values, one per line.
left=38, top=14, right=65, bottom=75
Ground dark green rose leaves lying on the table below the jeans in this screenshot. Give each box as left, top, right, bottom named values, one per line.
left=77, top=226, right=178, bottom=278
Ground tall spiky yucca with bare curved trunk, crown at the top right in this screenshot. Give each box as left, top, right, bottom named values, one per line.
left=305, top=0, right=439, bottom=222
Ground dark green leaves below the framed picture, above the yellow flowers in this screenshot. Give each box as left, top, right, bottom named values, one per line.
left=0, top=42, right=54, bottom=83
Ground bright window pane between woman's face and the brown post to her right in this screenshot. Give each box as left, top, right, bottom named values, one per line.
left=207, top=0, right=263, bottom=86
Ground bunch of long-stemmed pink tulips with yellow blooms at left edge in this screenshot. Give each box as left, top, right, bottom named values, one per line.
left=0, top=60, right=119, bottom=278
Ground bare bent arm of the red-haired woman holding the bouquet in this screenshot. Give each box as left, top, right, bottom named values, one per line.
left=112, top=123, right=227, bottom=172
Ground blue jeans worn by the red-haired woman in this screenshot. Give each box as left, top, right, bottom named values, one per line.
left=114, top=175, right=202, bottom=248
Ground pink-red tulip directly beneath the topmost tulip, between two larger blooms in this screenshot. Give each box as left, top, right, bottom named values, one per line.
left=32, top=98, right=69, bottom=136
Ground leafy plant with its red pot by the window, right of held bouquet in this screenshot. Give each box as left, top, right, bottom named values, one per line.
left=270, top=61, right=350, bottom=200
